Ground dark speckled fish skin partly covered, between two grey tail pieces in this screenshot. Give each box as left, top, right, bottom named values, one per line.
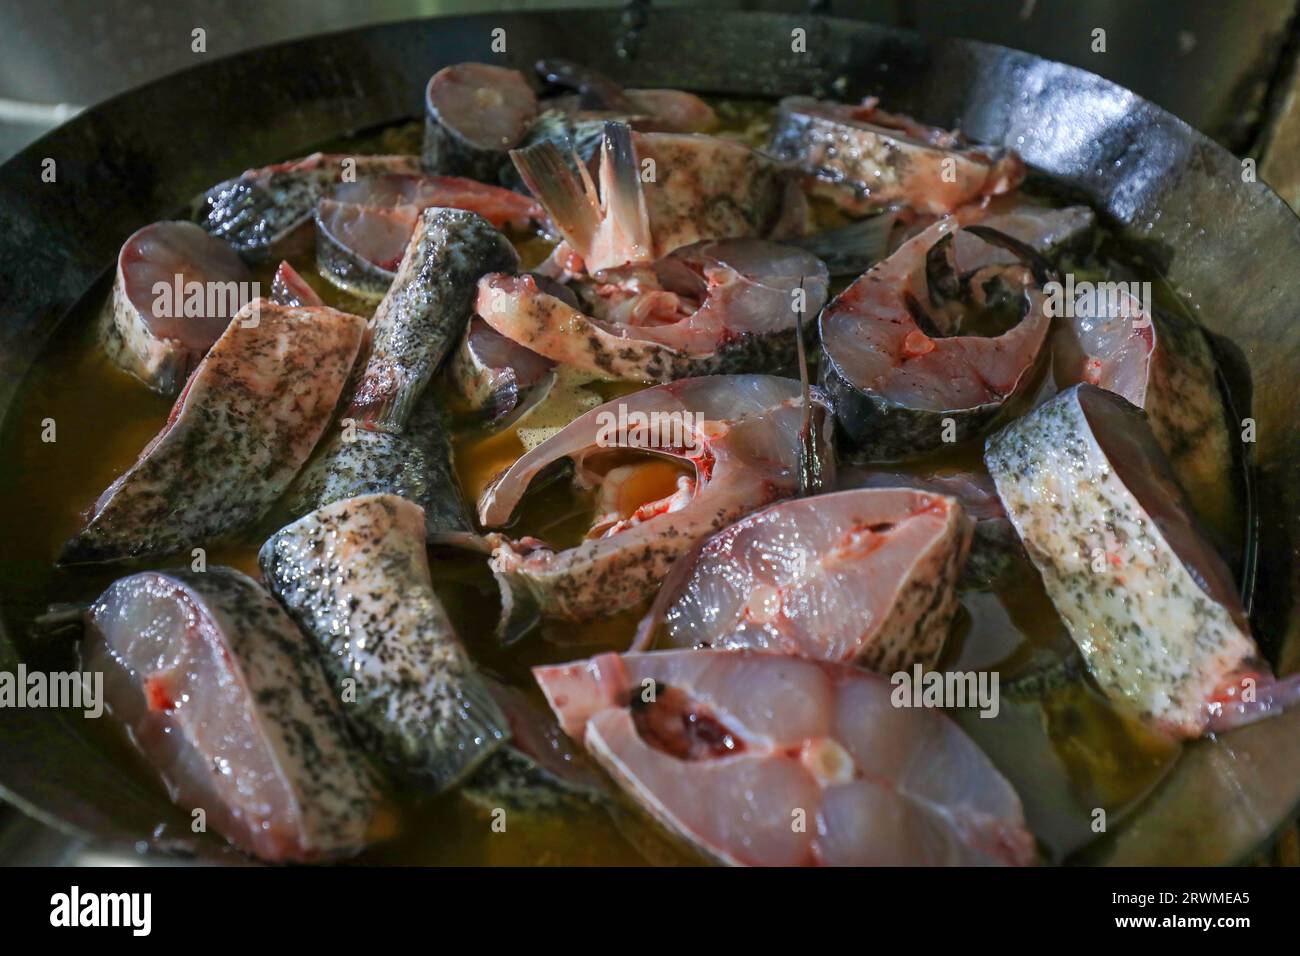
left=285, top=393, right=475, bottom=544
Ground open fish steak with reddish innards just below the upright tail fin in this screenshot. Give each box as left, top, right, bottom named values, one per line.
left=477, top=239, right=829, bottom=382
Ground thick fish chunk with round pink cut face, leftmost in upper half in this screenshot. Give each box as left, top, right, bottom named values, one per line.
left=100, top=221, right=248, bottom=394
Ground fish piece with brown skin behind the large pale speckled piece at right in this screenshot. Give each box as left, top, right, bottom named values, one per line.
left=1052, top=283, right=1236, bottom=529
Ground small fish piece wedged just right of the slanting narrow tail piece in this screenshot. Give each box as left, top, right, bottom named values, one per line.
left=450, top=316, right=564, bottom=423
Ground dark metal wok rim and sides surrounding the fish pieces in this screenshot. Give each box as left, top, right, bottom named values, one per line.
left=0, top=10, right=1300, bottom=864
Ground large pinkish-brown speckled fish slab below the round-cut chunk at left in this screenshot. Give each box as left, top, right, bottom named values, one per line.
left=59, top=299, right=365, bottom=564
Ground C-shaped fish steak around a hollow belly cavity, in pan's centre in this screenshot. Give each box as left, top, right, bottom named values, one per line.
left=478, top=375, right=833, bottom=620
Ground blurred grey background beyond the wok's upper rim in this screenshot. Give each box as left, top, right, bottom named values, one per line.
left=0, top=0, right=1300, bottom=192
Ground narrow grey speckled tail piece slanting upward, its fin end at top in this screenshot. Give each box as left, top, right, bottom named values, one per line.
left=345, top=207, right=519, bottom=432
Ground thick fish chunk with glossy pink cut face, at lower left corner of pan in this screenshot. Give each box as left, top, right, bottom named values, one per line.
left=83, top=567, right=381, bottom=862
